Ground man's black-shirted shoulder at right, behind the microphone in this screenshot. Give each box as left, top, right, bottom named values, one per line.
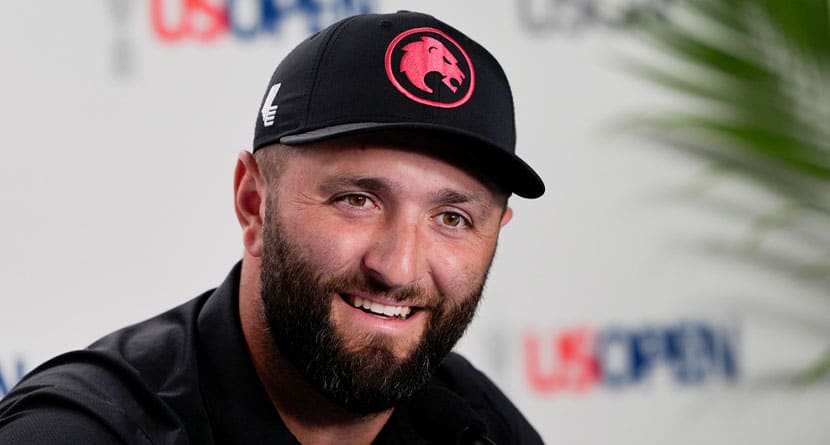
left=433, top=353, right=543, bottom=444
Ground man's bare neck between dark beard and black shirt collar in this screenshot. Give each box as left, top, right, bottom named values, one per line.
left=239, top=255, right=392, bottom=444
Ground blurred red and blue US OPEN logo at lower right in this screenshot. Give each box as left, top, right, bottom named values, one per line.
left=522, top=321, right=739, bottom=394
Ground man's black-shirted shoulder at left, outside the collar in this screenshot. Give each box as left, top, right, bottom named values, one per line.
left=0, top=299, right=211, bottom=444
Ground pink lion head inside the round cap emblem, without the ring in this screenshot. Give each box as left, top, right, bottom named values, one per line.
left=401, top=36, right=466, bottom=93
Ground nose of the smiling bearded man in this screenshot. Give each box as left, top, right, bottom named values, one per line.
left=363, top=215, right=427, bottom=289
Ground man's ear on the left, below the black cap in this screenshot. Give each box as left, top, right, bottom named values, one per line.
left=233, top=151, right=268, bottom=258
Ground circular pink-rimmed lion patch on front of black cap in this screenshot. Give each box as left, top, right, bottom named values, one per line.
left=385, top=28, right=475, bottom=108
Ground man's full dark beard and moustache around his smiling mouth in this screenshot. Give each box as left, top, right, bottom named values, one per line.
left=260, top=199, right=489, bottom=414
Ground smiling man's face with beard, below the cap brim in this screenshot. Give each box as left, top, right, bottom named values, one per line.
left=261, top=144, right=509, bottom=412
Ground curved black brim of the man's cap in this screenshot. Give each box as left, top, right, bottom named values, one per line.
left=280, top=122, right=545, bottom=199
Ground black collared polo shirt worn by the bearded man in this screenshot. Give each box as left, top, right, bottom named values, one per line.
left=0, top=264, right=542, bottom=445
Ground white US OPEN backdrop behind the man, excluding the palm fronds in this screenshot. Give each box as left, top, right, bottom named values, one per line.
left=0, top=0, right=830, bottom=444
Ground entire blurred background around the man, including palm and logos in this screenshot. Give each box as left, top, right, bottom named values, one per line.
left=0, top=0, right=830, bottom=444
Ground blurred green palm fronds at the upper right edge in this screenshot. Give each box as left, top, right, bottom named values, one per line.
left=626, top=0, right=830, bottom=382
